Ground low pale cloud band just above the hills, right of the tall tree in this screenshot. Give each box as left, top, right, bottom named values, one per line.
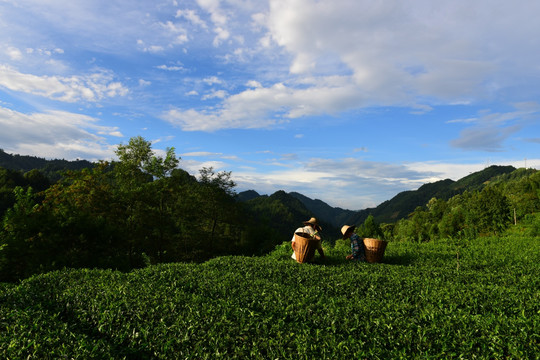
left=168, top=140, right=540, bottom=210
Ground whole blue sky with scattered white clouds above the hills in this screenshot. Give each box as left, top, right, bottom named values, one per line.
left=0, top=0, right=540, bottom=210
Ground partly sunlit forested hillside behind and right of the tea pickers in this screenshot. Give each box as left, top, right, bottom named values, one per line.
left=240, top=165, right=540, bottom=245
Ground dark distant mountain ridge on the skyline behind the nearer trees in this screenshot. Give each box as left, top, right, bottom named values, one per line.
left=0, top=149, right=516, bottom=231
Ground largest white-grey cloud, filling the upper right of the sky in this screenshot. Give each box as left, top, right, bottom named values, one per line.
left=158, top=0, right=540, bottom=130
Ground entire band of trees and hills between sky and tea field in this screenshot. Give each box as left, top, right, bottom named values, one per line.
left=0, top=137, right=540, bottom=281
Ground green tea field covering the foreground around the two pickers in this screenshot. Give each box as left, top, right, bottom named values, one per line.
left=0, top=237, right=540, bottom=359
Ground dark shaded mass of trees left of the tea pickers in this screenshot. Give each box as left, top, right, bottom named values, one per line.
left=0, top=137, right=294, bottom=281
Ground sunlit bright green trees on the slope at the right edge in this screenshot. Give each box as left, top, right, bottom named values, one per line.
left=393, top=169, right=540, bottom=241
